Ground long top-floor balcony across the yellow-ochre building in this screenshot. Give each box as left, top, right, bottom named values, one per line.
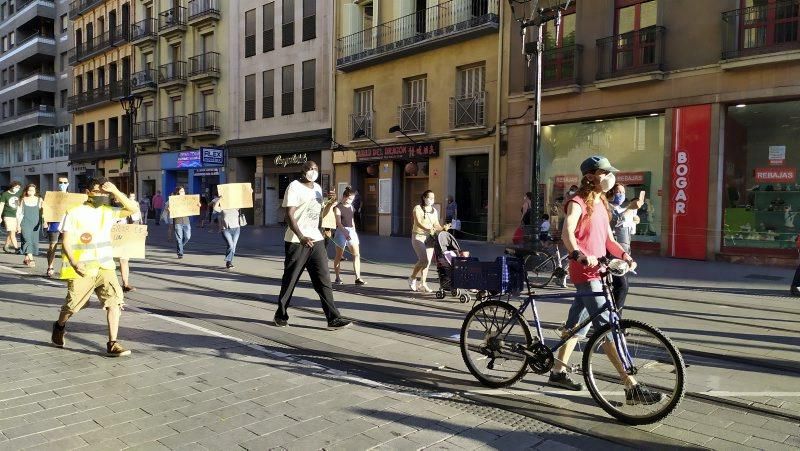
left=336, top=0, right=500, bottom=72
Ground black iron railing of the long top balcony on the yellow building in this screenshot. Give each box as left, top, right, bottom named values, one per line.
left=336, top=0, right=500, bottom=66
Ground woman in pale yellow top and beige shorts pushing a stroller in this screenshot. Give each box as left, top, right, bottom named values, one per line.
left=408, top=190, right=449, bottom=293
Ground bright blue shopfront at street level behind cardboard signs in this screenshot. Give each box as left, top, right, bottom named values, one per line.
left=161, top=147, right=226, bottom=199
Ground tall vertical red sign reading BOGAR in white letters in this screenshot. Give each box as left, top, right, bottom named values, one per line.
left=669, top=105, right=711, bottom=260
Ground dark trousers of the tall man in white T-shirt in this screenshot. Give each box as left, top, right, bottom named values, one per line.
left=275, top=241, right=341, bottom=322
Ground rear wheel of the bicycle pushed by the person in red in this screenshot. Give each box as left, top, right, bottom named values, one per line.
left=461, top=300, right=531, bottom=388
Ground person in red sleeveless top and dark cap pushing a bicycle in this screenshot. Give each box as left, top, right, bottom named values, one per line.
left=549, top=156, right=662, bottom=404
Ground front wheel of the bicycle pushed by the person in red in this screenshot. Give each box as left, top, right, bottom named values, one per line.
left=583, top=319, right=686, bottom=425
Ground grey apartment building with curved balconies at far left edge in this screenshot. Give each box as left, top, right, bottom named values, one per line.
left=0, top=0, right=72, bottom=191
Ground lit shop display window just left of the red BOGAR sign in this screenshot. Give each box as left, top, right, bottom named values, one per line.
left=541, top=114, right=665, bottom=251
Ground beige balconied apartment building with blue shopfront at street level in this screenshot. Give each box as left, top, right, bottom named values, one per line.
left=131, top=0, right=230, bottom=199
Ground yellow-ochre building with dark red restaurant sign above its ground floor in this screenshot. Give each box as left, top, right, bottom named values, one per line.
left=333, top=0, right=508, bottom=240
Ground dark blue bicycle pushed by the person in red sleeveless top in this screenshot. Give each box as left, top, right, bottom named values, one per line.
left=460, top=258, right=686, bottom=425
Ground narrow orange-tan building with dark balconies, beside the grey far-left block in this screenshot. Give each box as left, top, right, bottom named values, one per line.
left=67, top=0, right=135, bottom=192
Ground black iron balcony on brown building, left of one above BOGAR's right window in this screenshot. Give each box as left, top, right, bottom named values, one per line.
left=597, top=26, right=666, bottom=80
